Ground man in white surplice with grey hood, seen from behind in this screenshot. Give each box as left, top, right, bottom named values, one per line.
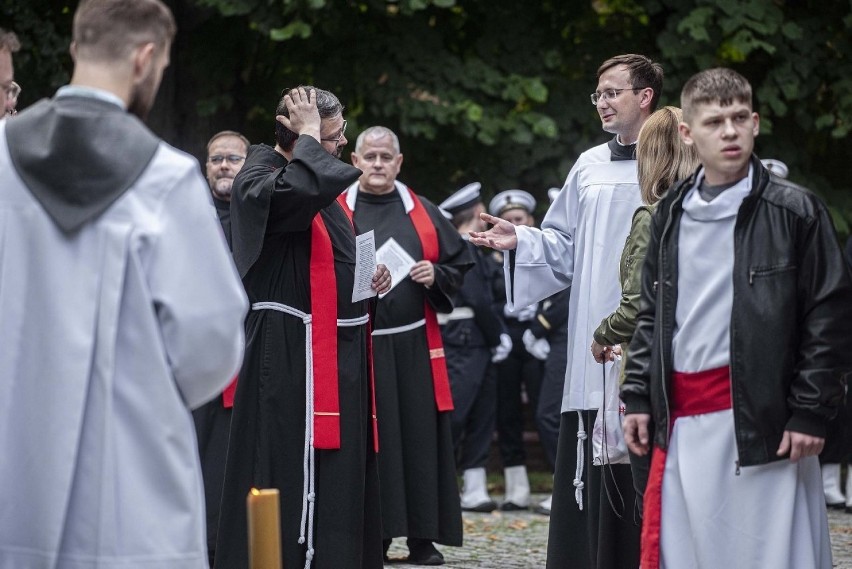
left=0, top=0, right=248, bottom=569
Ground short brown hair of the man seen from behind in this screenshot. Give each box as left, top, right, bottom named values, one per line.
left=71, top=0, right=177, bottom=61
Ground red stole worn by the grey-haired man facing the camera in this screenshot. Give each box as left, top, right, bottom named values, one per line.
left=337, top=190, right=453, bottom=411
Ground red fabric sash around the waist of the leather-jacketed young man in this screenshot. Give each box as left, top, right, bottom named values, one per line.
left=640, top=366, right=731, bottom=569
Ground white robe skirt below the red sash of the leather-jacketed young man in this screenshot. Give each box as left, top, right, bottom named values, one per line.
left=660, top=409, right=832, bottom=569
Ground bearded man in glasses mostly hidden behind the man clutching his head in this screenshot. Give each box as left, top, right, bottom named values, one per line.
left=192, top=126, right=251, bottom=567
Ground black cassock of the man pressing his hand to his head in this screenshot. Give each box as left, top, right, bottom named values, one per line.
left=216, top=136, right=382, bottom=569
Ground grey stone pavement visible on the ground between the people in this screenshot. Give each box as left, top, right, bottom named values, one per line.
left=385, top=496, right=852, bottom=569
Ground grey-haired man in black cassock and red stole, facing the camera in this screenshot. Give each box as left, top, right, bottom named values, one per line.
left=341, top=127, right=473, bottom=565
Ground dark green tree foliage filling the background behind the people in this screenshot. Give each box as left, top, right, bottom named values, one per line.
left=5, top=0, right=852, bottom=233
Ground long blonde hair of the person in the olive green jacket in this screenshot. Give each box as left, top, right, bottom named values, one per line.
left=636, top=107, right=698, bottom=205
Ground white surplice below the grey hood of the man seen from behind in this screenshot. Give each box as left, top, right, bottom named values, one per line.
left=0, top=126, right=247, bottom=569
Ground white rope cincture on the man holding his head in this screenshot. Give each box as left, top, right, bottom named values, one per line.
left=251, top=302, right=370, bottom=569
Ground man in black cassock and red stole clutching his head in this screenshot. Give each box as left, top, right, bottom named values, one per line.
left=216, top=87, right=390, bottom=569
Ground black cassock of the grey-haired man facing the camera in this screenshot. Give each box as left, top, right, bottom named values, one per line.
left=354, top=191, right=473, bottom=545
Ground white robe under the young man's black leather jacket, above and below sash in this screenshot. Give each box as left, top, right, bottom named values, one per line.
left=660, top=169, right=832, bottom=569
